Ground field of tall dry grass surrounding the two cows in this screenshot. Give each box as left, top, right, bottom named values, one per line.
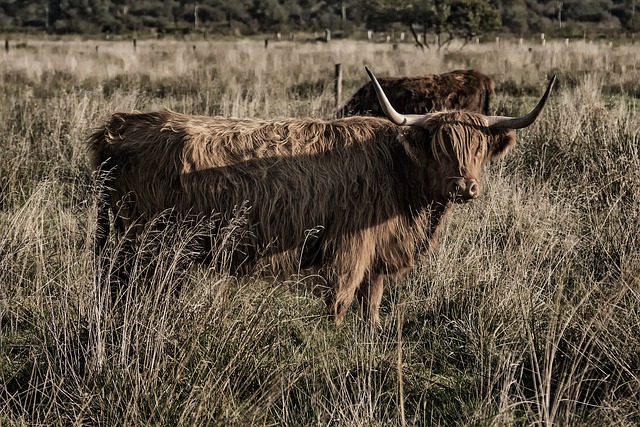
left=0, top=40, right=640, bottom=426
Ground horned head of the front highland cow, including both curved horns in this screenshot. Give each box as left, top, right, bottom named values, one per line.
left=365, top=67, right=556, bottom=203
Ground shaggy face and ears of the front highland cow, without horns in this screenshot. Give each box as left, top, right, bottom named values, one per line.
left=422, top=111, right=515, bottom=203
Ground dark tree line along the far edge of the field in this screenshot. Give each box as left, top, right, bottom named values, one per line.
left=0, top=0, right=640, bottom=40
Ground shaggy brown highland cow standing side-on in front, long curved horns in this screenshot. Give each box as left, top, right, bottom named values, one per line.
left=89, top=69, right=555, bottom=326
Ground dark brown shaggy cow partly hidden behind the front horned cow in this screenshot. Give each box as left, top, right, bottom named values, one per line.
left=337, top=70, right=495, bottom=117
